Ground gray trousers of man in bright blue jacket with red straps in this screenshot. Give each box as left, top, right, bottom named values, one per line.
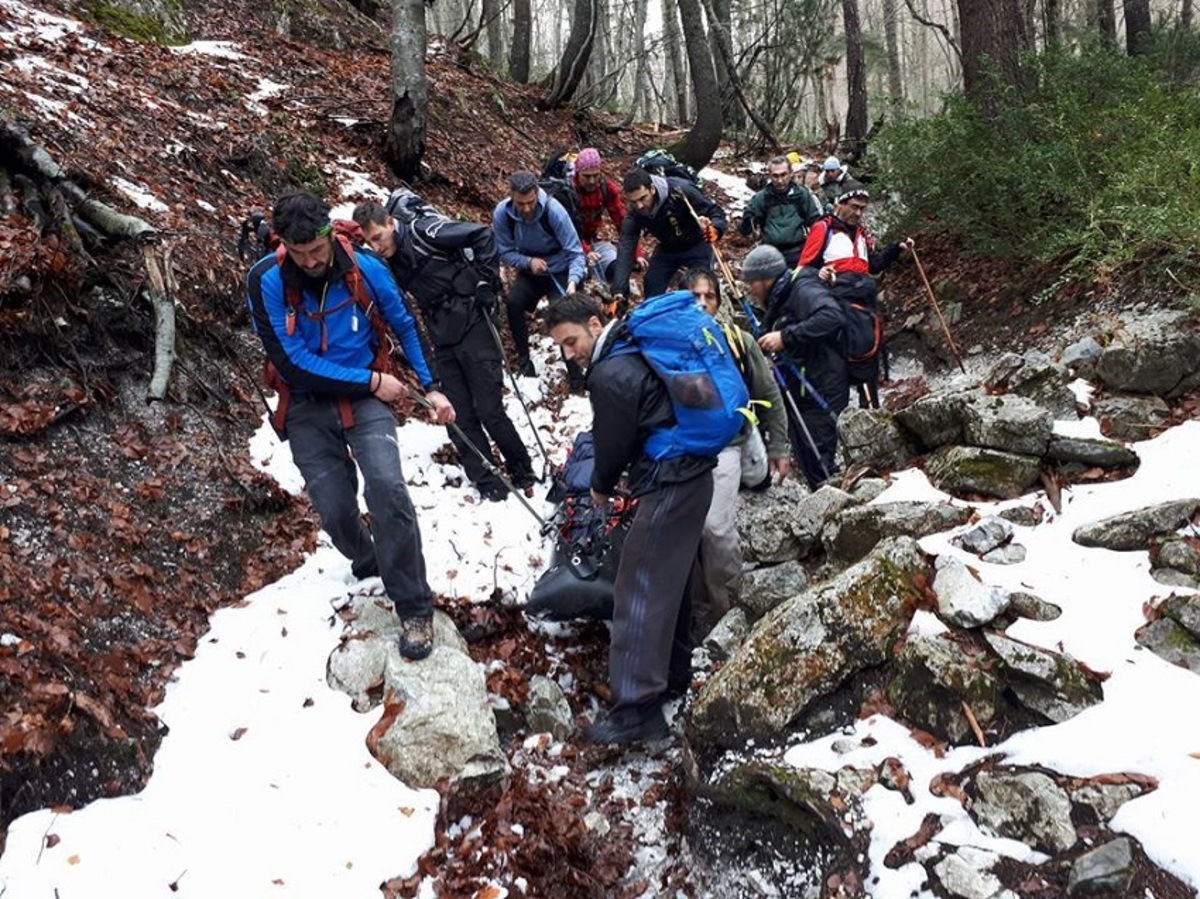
left=287, top=394, right=433, bottom=618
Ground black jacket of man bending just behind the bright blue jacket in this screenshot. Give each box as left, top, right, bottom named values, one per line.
left=388, top=215, right=500, bottom=347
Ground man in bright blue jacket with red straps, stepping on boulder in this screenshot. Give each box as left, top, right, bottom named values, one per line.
left=246, top=191, right=455, bottom=659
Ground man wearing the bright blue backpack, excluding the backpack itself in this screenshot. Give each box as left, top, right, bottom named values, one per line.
left=546, top=294, right=716, bottom=743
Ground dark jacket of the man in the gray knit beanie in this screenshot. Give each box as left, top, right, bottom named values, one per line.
left=763, top=269, right=850, bottom=412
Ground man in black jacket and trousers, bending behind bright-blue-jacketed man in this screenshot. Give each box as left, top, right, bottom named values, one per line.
left=354, top=192, right=535, bottom=502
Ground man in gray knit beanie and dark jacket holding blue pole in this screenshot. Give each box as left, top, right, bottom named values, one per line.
left=742, top=245, right=850, bottom=490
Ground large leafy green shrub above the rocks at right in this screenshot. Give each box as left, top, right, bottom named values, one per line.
left=872, top=43, right=1200, bottom=276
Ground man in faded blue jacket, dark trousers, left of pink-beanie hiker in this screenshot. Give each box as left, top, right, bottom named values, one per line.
left=492, top=172, right=587, bottom=380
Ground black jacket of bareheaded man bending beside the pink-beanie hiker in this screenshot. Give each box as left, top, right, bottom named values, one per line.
left=612, top=175, right=727, bottom=294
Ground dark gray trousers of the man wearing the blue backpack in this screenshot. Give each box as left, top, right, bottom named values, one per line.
left=608, top=472, right=713, bottom=713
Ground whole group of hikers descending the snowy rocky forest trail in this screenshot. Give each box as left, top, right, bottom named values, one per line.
left=238, top=148, right=902, bottom=744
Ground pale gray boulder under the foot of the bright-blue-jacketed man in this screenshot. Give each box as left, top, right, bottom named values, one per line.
left=328, top=598, right=509, bottom=789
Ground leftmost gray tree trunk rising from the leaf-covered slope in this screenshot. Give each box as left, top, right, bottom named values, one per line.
left=384, top=0, right=430, bottom=181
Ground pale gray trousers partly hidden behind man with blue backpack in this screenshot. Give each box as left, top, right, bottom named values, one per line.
left=691, top=443, right=742, bottom=639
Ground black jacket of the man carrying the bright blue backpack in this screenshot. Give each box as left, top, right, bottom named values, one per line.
left=588, top=322, right=716, bottom=496
